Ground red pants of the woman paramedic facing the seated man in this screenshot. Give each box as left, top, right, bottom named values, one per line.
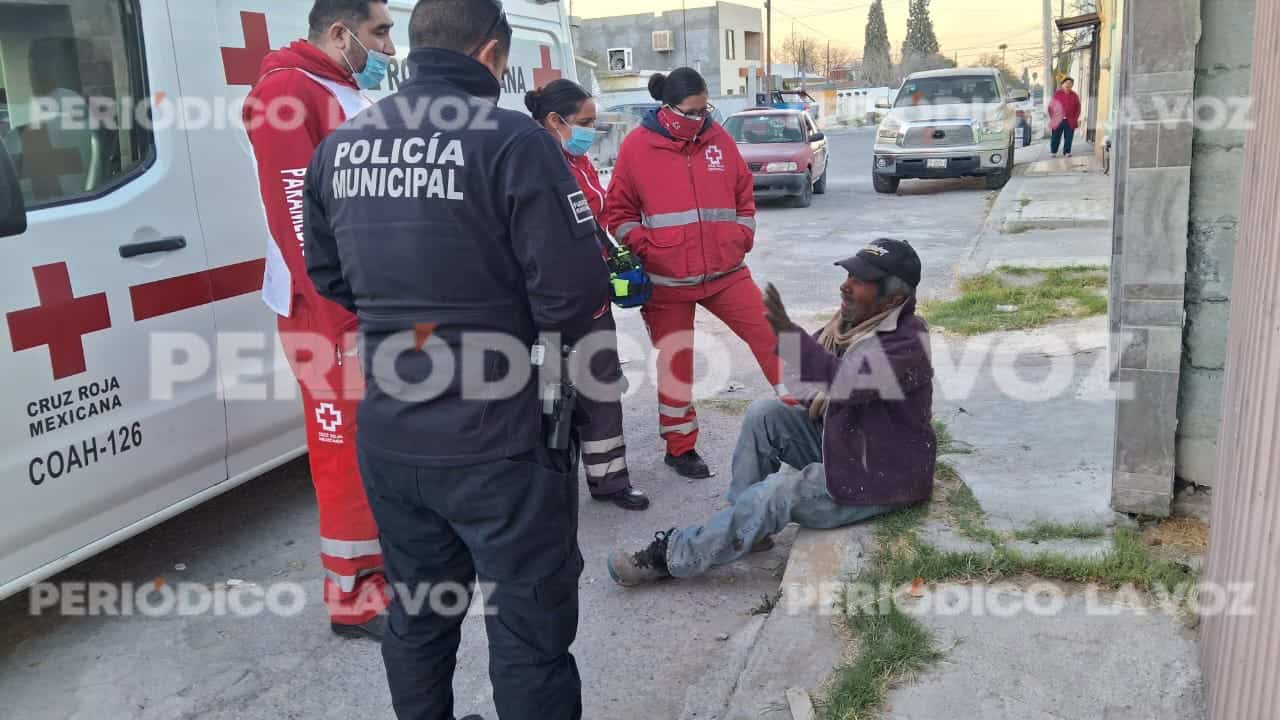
left=641, top=270, right=786, bottom=456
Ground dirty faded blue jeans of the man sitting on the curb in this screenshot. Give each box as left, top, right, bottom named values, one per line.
left=667, top=400, right=901, bottom=578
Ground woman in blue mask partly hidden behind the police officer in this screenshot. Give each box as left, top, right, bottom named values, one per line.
left=525, top=79, right=649, bottom=510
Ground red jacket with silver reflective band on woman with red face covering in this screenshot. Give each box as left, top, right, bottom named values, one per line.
left=602, top=111, right=755, bottom=287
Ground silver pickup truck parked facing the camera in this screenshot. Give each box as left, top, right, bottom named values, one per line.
left=872, top=68, right=1028, bottom=193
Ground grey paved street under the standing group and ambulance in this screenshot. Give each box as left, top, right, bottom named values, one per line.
left=0, top=129, right=1018, bottom=720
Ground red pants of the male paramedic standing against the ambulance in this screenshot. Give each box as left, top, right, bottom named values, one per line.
left=279, top=307, right=389, bottom=625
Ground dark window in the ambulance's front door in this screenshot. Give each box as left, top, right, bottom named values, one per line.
left=0, top=0, right=152, bottom=209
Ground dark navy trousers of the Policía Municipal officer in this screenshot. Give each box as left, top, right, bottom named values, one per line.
left=360, top=448, right=582, bottom=720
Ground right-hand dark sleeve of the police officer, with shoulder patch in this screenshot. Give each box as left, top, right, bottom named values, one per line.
left=498, top=128, right=609, bottom=343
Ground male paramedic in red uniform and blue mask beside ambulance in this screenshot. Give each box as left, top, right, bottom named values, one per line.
left=244, top=0, right=396, bottom=639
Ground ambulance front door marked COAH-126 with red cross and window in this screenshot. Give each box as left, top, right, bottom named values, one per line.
left=0, top=0, right=227, bottom=589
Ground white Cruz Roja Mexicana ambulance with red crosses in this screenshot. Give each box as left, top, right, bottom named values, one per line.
left=0, top=0, right=576, bottom=598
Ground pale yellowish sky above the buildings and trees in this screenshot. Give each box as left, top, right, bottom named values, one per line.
left=562, top=0, right=1049, bottom=70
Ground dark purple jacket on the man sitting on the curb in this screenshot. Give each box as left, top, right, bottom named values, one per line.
left=783, top=300, right=938, bottom=505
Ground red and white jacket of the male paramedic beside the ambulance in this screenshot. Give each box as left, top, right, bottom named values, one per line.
left=244, top=40, right=370, bottom=338
